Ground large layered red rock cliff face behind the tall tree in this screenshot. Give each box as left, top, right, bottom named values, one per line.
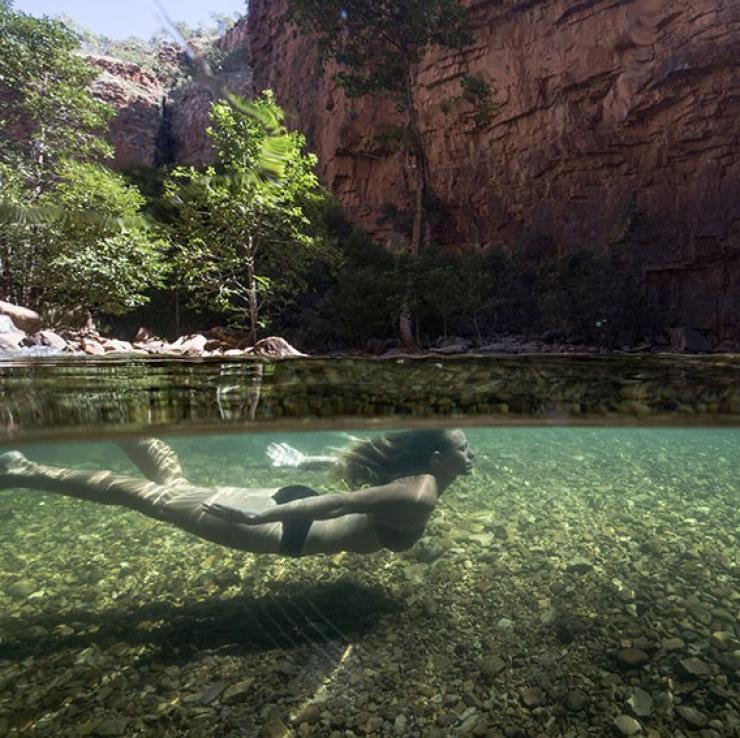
left=248, top=0, right=740, bottom=343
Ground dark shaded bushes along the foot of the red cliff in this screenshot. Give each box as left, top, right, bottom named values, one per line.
left=289, top=236, right=660, bottom=350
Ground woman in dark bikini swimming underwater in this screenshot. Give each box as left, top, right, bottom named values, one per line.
left=0, top=430, right=474, bottom=556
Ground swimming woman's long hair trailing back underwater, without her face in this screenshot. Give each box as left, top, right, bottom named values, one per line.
left=337, top=429, right=451, bottom=486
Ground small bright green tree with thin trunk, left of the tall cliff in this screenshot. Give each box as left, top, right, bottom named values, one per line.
left=165, top=92, right=324, bottom=342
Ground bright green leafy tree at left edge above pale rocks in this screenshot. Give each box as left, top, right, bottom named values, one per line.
left=0, top=3, right=163, bottom=320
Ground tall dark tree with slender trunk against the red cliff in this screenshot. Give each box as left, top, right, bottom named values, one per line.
left=290, top=0, right=471, bottom=254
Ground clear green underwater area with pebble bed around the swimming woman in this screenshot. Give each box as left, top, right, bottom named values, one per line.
left=0, top=426, right=740, bottom=738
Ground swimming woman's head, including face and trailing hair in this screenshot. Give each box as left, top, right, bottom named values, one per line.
left=341, top=429, right=473, bottom=485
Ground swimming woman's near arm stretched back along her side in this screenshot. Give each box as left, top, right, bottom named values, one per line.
left=204, top=476, right=437, bottom=525
